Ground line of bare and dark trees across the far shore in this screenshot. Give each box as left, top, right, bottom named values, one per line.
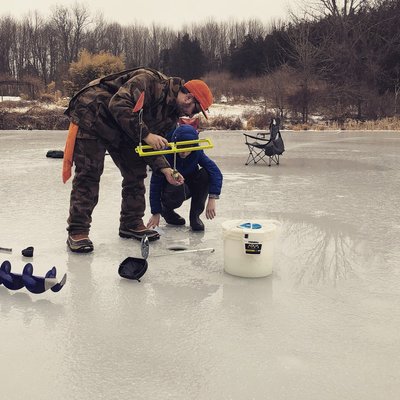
left=0, top=0, right=400, bottom=122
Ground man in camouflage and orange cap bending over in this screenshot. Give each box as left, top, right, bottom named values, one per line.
left=64, top=68, right=213, bottom=252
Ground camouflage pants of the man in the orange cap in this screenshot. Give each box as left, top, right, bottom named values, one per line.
left=67, top=136, right=147, bottom=234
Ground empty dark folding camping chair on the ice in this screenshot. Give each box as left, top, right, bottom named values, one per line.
left=243, top=118, right=285, bottom=167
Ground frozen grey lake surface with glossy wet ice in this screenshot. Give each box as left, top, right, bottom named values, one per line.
left=0, top=131, right=400, bottom=400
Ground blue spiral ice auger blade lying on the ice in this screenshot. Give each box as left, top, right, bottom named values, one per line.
left=0, top=260, right=67, bottom=293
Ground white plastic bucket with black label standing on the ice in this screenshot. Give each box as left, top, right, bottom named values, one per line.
left=222, top=220, right=281, bottom=278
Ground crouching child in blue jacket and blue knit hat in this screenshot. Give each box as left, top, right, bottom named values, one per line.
left=147, top=125, right=222, bottom=231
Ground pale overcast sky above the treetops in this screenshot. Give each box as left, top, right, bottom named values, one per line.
left=0, top=0, right=296, bottom=29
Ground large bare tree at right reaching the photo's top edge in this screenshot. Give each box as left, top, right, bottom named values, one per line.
left=292, top=0, right=397, bottom=119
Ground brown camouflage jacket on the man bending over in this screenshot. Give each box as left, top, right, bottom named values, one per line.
left=65, top=68, right=184, bottom=170
